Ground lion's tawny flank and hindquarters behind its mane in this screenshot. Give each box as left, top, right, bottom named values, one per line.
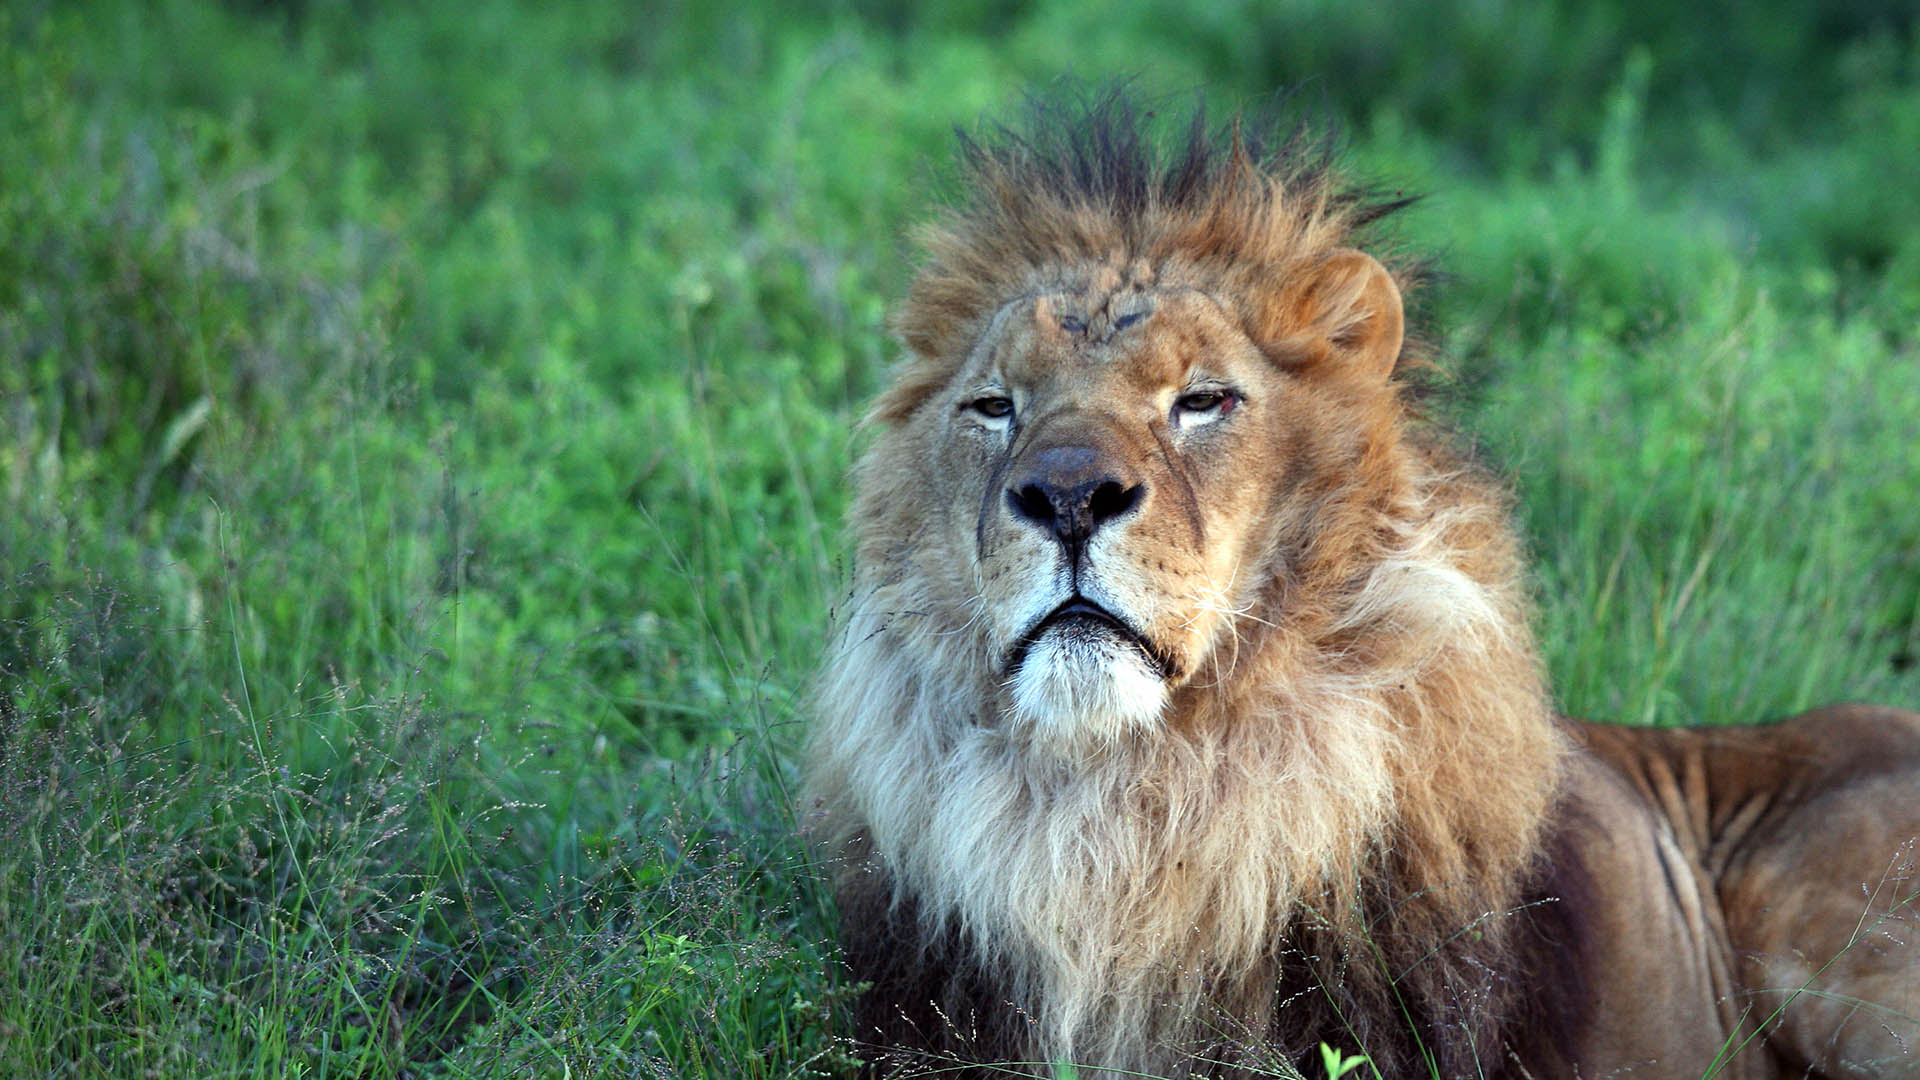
left=1559, top=705, right=1920, bottom=1078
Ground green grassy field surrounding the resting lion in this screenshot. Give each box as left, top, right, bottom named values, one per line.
left=0, top=0, right=1920, bottom=1078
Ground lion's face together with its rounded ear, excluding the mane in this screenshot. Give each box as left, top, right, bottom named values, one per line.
left=881, top=242, right=1402, bottom=755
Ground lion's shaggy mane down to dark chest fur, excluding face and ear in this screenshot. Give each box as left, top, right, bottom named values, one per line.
left=808, top=98, right=1563, bottom=1076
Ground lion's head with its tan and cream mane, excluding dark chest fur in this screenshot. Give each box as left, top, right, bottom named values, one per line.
left=810, top=102, right=1557, bottom=1067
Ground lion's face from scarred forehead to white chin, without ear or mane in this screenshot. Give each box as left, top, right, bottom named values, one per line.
left=920, top=259, right=1400, bottom=740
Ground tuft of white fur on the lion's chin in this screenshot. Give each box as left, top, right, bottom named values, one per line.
left=1014, top=628, right=1167, bottom=749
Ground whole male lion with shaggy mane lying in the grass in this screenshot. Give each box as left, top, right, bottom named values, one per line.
left=808, top=102, right=1920, bottom=1080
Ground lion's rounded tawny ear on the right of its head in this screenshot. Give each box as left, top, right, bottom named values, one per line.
left=1258, top=248, right=1407, bottom=382
